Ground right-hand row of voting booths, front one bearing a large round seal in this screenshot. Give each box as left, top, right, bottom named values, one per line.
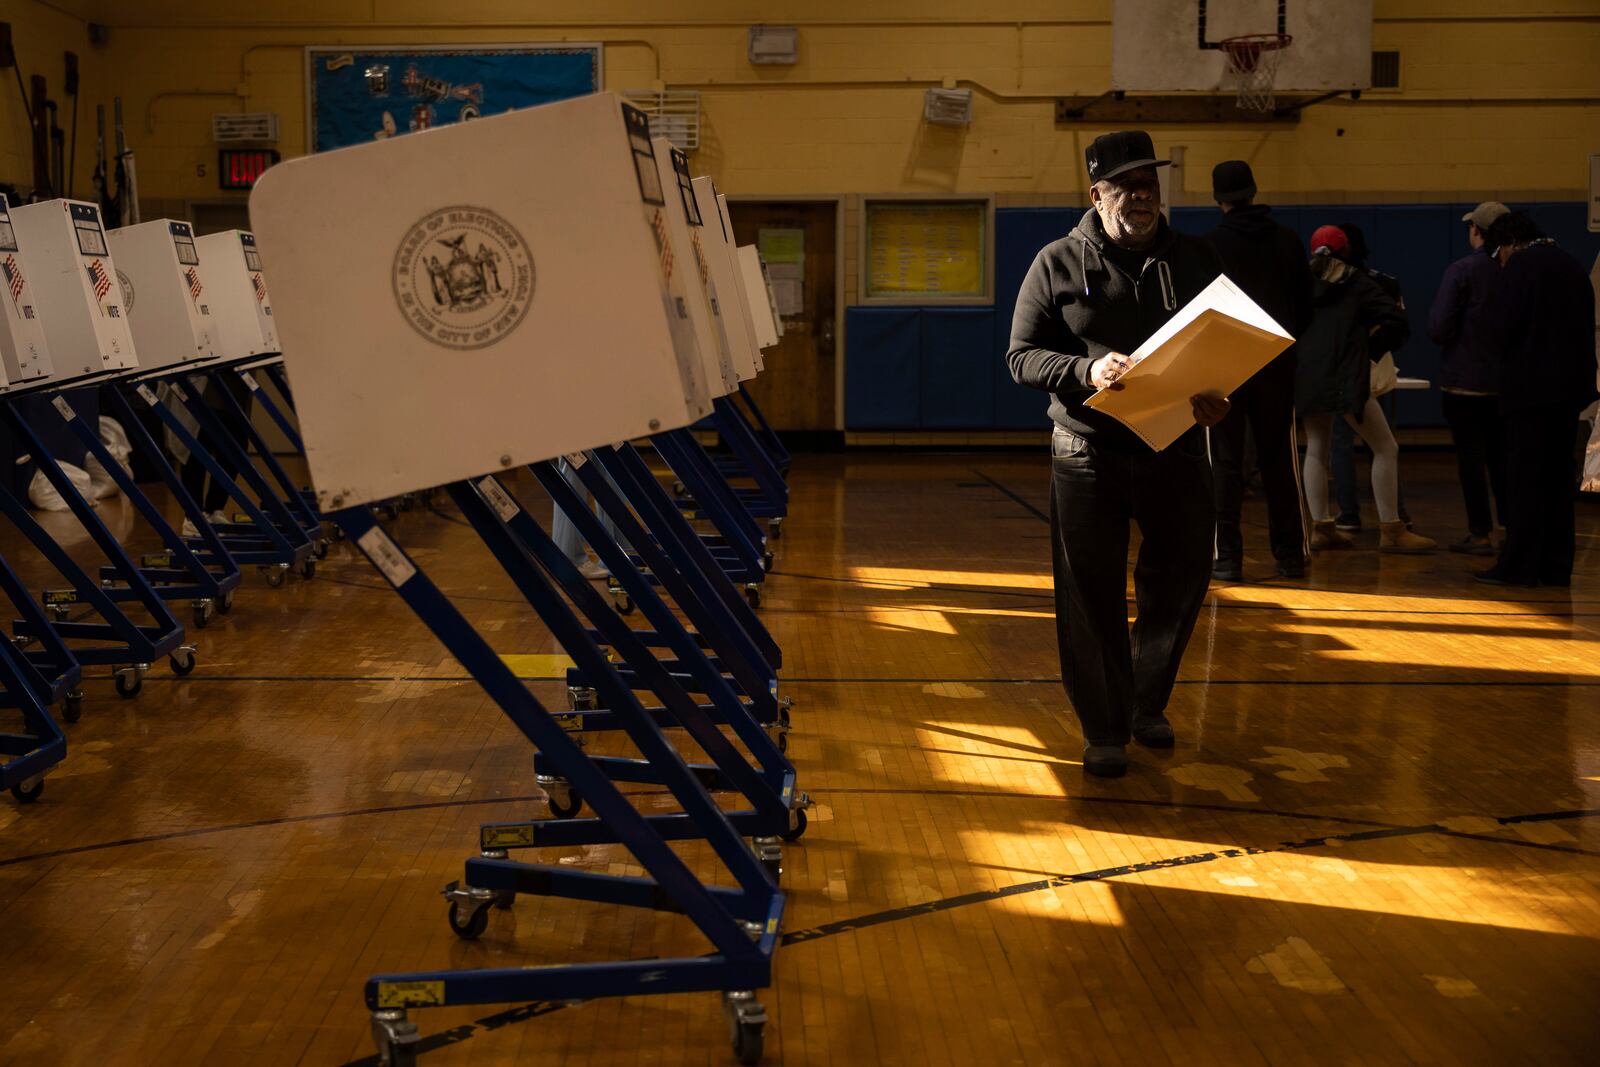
left=251, top=93, right=793, bottom=1065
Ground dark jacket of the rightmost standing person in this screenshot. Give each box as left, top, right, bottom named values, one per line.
left=1496, top=242, right=1595, bottom=418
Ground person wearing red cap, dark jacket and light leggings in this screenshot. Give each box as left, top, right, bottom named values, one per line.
left=1294, top=226, right=1435, bottom=553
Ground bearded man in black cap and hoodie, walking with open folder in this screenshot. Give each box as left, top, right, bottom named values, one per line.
left=1006, top=130, right=1229, bottom=777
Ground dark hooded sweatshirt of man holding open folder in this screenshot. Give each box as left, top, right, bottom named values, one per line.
left=1006, top=208, right=1221, bottom=450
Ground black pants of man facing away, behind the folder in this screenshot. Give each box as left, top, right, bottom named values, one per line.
left=1211, top=355, right=1306, bottom=563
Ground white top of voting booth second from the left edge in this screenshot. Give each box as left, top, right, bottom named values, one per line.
left=11, top=200, right=139, bottom=384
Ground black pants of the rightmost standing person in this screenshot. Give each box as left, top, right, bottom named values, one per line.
left=1496, top=406, right=1578, bottom=585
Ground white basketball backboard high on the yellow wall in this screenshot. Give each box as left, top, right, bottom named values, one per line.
left=1110, top=0, right=1373, bottom=93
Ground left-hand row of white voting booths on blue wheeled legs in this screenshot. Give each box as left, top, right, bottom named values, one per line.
left=0, top=183, right=326, bottom=803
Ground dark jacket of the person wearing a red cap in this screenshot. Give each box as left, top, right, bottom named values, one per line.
left=1294, top=264, right=1405, bottom=416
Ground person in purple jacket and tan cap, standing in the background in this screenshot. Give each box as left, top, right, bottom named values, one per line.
left=1427, top=200, right=1507, bottom=555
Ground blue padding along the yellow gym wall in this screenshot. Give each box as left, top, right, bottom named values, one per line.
left=845, top=202, right=1600, bottom=430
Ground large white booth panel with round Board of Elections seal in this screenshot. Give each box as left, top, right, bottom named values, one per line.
left=254, top=93, right=709, bottom=509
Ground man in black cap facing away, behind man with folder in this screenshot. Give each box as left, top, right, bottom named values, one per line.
left=1206, top=160, right=1312, bottom=582
